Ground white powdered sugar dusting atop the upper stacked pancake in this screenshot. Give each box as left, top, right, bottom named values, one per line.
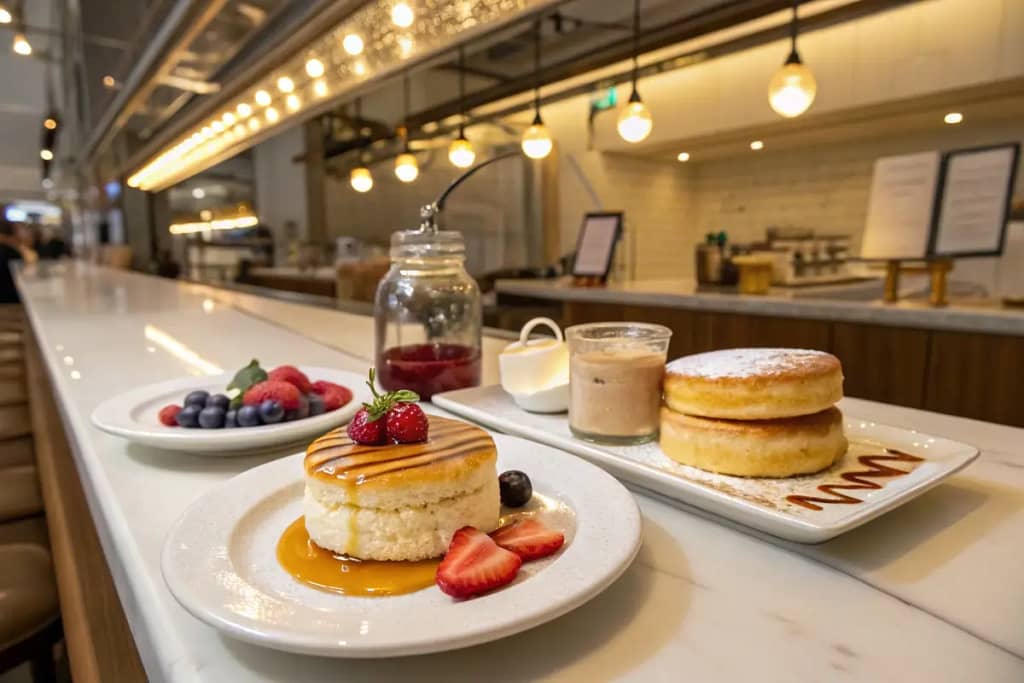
left=668, top=348, right=829, bottom=379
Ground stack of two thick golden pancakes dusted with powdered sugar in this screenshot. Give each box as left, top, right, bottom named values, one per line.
left=660, top=348, right=847, bottom=477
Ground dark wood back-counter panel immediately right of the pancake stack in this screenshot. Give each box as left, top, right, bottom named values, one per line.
left=831, top=323, right=929, bottom=408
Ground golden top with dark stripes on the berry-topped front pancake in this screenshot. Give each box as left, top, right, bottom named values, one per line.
left=305, top=418, right=495, bottom=485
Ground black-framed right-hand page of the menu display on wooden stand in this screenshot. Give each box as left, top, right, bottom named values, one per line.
left=929, top=143, right=1021, bottom=256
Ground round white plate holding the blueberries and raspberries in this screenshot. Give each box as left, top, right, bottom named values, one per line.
left=92, top=366, right=370, bottom=456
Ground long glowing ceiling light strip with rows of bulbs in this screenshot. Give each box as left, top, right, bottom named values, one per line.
left=128, top=0, right=558, bottom=191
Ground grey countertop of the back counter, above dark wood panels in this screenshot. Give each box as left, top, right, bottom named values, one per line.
left=495, top=278, right=1024, bottom=336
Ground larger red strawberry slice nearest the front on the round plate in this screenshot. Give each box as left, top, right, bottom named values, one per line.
left=436, top=526, right=522, bottom=598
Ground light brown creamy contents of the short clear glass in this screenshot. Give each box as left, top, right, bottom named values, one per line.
left=569, top=349, right=665, bottom=440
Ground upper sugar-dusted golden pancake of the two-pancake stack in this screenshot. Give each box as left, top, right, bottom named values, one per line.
left=665, top=348, right=843, bottom=420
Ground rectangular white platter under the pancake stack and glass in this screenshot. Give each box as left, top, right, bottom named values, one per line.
left=433, top=386, right=978, bottom=543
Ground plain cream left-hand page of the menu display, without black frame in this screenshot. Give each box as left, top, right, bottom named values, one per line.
left=860, top=151, right=942, bottom=259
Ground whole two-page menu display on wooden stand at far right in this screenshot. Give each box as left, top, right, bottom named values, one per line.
left=861, top=143, right=1020, bottom=259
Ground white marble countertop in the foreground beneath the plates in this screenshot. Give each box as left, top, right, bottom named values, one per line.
left=19, top=263, right=1024, bottom=683
